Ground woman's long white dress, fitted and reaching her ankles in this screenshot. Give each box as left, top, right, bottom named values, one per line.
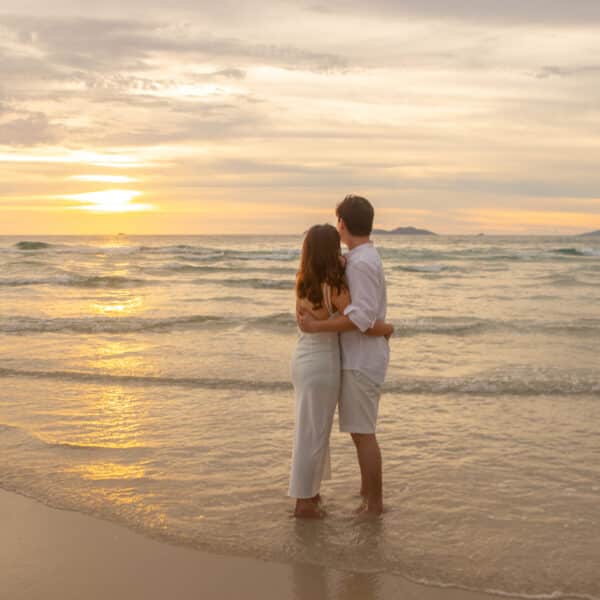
left=288, top=286, right=341, bottom=498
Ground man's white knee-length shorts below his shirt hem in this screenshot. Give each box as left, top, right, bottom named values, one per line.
left=339, top=370, right=381, bottom=433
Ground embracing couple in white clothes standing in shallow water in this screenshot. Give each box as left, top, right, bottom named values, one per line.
left=288, top=195, right=394, bottom=518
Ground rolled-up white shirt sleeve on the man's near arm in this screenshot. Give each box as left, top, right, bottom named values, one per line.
left=344, top=261, right=380, bottom=333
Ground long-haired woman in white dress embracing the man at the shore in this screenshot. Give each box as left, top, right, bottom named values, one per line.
left=288, top=225, right=394, bottom=518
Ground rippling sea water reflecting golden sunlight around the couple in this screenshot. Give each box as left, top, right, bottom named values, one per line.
left=0, top=235, right=600, bottom=600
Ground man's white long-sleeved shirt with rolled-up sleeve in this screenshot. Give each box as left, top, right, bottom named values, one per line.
left=340, top=242, right=390, bottom=385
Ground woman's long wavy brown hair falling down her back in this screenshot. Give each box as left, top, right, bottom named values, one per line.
left=296, top=225, right=346, bottom=308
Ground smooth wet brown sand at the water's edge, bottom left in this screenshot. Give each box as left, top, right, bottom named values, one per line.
left=0, top=489, right=498, bottom=600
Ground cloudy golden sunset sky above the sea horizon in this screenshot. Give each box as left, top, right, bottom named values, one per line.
left=0, top=0, right=600, bottom=235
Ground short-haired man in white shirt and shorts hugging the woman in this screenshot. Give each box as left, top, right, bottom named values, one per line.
left=298, top=195, right=389, bottom=515
